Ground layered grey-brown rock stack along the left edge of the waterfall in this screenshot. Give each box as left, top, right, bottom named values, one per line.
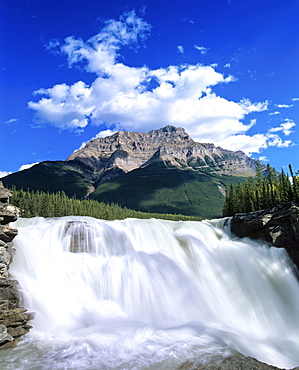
left=0, top=181, right=33, bottom=349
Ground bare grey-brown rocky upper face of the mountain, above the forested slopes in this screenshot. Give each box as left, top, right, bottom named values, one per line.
left=67, top=126, right=257, bottom=183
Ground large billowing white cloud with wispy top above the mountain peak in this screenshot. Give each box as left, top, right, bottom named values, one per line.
left=28, top=11, right=290, bottom=153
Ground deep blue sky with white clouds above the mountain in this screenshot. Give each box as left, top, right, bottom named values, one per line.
left=0, top=0, right=299, bottom=175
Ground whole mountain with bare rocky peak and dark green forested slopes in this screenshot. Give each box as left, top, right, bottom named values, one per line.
left=2, top=126, right=258, bottom=218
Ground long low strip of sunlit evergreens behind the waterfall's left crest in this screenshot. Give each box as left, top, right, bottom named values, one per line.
left=11, top=188, right=199, bottom=221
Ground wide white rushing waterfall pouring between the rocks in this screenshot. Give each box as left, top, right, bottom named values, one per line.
left=0, top=217, right=299, bottom=370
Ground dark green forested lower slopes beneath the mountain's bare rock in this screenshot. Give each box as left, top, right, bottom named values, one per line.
left=2, top=158, right=251, bottom=218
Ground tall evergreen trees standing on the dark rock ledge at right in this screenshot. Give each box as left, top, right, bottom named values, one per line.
left=223, top=164, right=299, bottom=217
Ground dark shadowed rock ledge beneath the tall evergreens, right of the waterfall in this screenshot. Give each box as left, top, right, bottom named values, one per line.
left=230, top=202, right=299, bottom=268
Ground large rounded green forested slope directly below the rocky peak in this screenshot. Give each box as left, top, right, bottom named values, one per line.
left=89, top=162, right=246, bottom=218
